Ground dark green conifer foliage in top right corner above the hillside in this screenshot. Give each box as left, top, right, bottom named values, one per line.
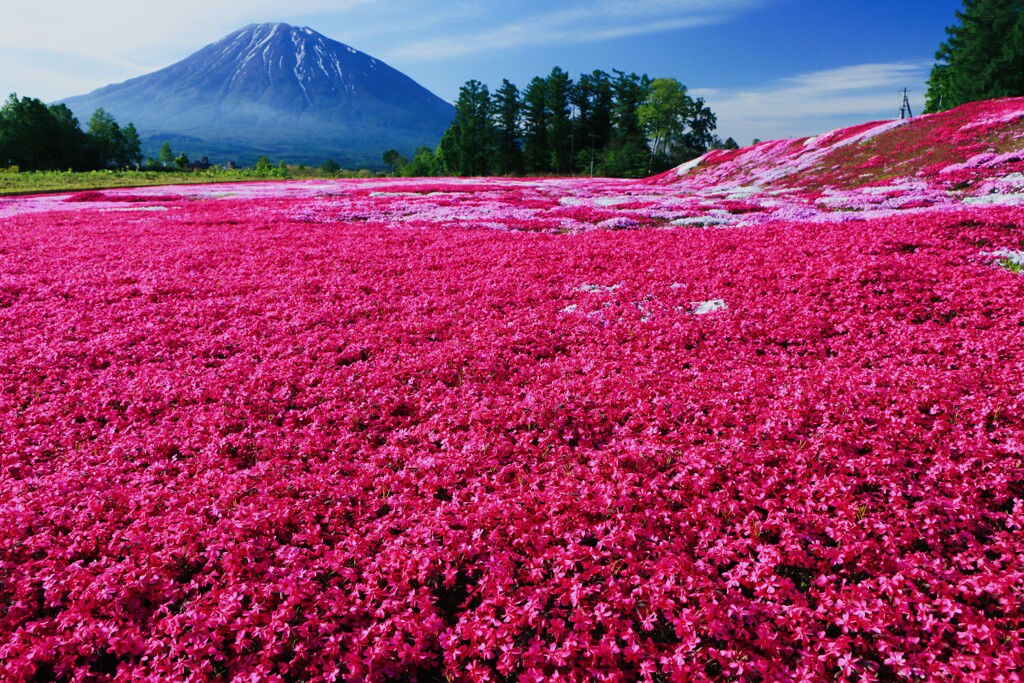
left=925, top=0, right=1024, bottom=112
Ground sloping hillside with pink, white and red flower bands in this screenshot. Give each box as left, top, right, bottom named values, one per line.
left=657, top=97, right=1024, bottom=198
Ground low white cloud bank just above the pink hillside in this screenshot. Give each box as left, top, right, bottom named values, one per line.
left=693, top=62, right=931, bottom=142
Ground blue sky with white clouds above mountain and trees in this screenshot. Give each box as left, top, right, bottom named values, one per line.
left=0, top=0, right=962, bottom=144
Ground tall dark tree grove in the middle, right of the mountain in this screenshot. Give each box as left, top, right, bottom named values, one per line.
left=384, top=67, right=736, bottom=177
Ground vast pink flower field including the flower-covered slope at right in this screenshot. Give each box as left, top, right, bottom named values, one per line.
left=0, top=99, right=1024, bottom=683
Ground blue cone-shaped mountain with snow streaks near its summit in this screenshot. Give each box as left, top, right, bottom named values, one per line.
left=63, top=24, right=455, bottom=165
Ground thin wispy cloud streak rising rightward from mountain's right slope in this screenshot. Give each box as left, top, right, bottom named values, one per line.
left=385, top=0, right=767, bottom=59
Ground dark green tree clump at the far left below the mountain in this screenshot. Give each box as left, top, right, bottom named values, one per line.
left=0, top=94, right=142, bottom=171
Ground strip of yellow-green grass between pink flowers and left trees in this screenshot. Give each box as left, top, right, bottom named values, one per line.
left=0, top=166, right=385, bottom=196
